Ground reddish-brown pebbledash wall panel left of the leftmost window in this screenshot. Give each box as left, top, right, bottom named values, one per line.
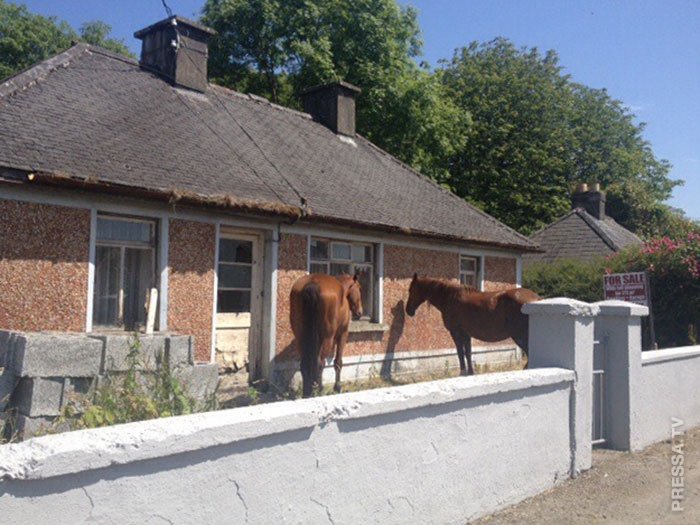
left=0, top=199, right=90, bottom=332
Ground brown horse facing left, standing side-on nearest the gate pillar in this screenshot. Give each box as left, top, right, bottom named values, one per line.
left=406, top=274, right=540, bottom=375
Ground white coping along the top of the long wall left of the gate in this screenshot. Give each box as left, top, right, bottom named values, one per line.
left=0, top=368, right=574, bottom=480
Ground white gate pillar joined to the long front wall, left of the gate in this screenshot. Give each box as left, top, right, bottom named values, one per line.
left=523, top=298, right=599, bottom=476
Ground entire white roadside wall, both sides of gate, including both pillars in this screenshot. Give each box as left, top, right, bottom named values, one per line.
left=0, top=299, right=700, bottom=524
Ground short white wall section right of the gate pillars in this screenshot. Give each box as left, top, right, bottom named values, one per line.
left=633, top=346, right=700, bottom=449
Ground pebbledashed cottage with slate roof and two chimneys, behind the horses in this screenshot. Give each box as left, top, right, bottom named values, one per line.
left=0, top=16, right=537, bottom=380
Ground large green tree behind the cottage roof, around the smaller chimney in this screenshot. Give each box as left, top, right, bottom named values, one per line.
left=202, top=0, right=470, bottom=180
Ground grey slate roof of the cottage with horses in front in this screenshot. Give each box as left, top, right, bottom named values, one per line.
left=0, top=44, right=536, bottom=251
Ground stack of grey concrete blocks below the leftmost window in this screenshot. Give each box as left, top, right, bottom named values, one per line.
left=0, top=332, right=218, bottom=437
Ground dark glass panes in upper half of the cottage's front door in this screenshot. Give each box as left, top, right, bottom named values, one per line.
left=216, top=238, right=253, bottom=313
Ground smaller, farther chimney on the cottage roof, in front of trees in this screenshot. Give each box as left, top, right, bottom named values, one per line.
left=301, top=81, right=361, bottom=137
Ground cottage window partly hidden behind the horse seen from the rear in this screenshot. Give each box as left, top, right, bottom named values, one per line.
left=309, top=238, right=375, bottom=319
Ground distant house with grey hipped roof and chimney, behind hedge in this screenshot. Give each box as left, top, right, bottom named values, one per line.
left=523, top=184, right=642, bottom=265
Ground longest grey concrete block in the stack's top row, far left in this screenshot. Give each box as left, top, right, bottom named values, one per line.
left=12, top=333, right=102, bottom=377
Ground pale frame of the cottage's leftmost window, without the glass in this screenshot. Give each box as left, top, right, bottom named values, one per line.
left=91, top=212, right=160, bottom=331
